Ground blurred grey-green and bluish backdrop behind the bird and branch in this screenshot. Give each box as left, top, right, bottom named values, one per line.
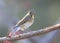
left=0, top=0, right=60, bottom=43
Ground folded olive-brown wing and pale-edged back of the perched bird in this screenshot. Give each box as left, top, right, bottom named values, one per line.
left=16, top=11, right=33, bottom=26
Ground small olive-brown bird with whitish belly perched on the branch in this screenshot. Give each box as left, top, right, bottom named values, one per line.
left=5, top=11, right=35, bottom=43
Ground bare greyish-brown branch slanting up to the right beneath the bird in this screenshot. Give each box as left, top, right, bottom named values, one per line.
left=0, top=24, right=60, bottom=41
